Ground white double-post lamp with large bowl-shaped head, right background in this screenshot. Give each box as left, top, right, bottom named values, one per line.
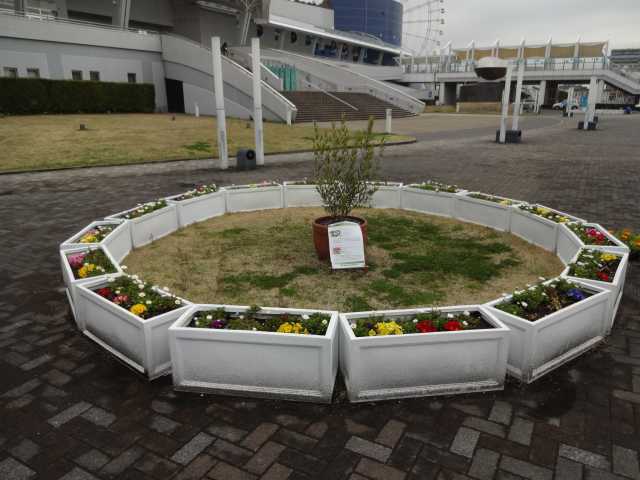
left=475, top=57, right=524, bottom=143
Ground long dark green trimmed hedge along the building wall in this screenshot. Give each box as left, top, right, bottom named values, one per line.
left=0, top=78, right=155, bottom=115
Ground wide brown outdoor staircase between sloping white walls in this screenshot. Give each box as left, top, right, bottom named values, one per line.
left=281, top=91, right=414, bottom=123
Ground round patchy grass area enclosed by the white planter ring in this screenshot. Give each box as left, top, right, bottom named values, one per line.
left=125, top=208, right=562, bottom=311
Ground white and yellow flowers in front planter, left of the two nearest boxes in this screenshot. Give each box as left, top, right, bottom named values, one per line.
left=188, top=306, right=331, bottom=335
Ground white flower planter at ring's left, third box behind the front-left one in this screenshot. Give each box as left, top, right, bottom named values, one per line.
left=107, top=199, right=178, bottom=248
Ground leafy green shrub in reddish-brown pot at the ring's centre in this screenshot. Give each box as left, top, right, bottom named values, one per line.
left=313, top=118, right=384, bottom=260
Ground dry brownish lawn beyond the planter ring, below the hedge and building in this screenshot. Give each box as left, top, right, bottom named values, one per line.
left=0, top=114, right=411, bottom=171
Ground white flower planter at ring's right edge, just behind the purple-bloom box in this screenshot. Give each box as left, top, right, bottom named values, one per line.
left=563, top=248, right=629, bottom=334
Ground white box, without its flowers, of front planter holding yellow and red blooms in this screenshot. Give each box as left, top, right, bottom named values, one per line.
left=340, top=306, right=509, bottom=402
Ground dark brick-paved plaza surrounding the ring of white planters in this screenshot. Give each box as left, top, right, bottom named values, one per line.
left=0, top=115, right=640, bottom=480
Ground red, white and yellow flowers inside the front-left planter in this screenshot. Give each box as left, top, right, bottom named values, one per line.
left=95, top=275, right=183, bottom=319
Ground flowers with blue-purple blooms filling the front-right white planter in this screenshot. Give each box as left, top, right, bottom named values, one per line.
left=495, top=278, right=592, bottom=322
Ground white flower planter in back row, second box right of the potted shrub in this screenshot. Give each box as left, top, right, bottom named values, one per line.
left=402, top=180, right=465, bottom=217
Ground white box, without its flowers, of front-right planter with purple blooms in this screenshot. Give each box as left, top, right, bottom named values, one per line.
left=487, top=282, right=610, bottom=383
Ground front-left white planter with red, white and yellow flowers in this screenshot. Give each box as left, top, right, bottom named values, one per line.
left=76, top=275, right=190, bottom=379
